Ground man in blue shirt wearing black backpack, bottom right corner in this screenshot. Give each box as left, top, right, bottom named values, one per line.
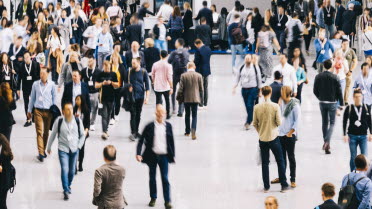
left=338, top=154, right=372, bottom=209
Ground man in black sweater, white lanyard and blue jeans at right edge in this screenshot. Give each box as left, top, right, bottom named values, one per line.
left=343, top=89, right=372, bottom=171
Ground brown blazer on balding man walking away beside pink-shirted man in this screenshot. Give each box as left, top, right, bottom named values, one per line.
left=177, top=71, right=204, bottom=103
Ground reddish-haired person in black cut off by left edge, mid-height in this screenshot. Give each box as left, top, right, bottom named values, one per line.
left=0, top=82, right=17, bottom=141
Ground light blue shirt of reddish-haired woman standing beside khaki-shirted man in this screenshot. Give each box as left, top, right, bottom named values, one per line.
left=279, top=101, right=301, bottom=136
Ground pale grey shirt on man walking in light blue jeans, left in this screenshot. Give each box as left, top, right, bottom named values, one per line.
left=47, top=117, right=85, bottom=153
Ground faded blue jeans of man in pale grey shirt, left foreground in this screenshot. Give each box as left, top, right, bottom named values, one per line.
left=58, top=150, right=79, bottom=192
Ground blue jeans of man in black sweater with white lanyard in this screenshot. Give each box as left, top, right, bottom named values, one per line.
left=349, top=134, right=368, bottom=171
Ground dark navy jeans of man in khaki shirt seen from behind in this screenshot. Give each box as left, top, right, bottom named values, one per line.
left=259, top=137, right=288, bottom=189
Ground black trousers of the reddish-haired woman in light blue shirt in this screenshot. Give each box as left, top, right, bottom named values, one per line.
left=279, top=135, right=296, bottom=182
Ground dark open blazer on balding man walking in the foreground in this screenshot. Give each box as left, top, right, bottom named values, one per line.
left=137, top=122, right=175, bottom=164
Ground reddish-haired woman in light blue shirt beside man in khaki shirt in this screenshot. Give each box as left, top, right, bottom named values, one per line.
left=272, top=86, right=301, bottom=188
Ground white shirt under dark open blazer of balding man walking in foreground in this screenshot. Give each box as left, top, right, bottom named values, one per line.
left=152, top=121, right=168, bottom=155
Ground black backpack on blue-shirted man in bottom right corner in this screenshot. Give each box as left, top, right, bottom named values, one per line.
left=338, top=175, right=366, bottom=209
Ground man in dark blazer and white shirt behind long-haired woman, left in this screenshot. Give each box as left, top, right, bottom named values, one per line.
left=61, top=69, right=90, bottom=110
